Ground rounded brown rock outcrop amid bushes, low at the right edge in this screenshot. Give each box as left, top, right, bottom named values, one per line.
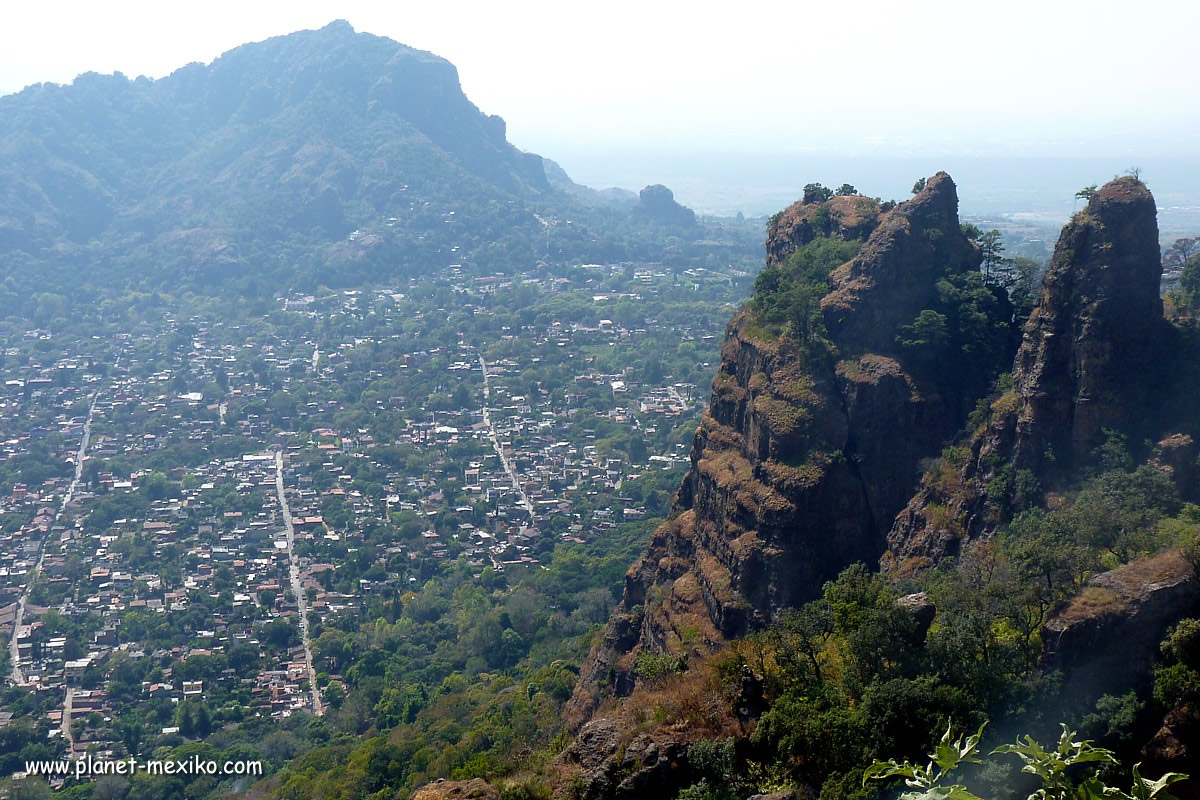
left=1042, top=551, right=1200, bottom=708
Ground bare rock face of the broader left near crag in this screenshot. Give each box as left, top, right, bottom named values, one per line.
left=570, top=173, right=1003, bottom=722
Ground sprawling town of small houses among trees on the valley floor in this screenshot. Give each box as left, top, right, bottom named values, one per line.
left=0, top=264, right=750, bottom=782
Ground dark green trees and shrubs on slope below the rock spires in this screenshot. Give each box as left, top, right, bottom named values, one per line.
left=667, top=443, right=1200, bottom=800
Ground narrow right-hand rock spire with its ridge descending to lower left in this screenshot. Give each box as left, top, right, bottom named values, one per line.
left=883, top=178, right=1169, bottom=573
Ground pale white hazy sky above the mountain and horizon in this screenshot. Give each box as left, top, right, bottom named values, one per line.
left=0, top=0, right=1200, bottom=164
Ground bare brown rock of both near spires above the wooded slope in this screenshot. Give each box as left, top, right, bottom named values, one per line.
left=571, top=174, right=1195, bottom=721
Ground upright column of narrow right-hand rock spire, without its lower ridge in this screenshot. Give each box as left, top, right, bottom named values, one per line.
left=1013, top=178, right=1165, bottom=470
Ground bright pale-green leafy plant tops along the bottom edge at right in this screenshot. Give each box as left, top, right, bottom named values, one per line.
left=863, top=726, right=1188, bottom=800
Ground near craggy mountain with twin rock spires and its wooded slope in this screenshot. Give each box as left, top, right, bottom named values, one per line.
left=542, top=174, right=1200, bottom=799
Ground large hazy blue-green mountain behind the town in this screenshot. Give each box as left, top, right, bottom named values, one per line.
left=0, top=22, right=720, bottom=294
